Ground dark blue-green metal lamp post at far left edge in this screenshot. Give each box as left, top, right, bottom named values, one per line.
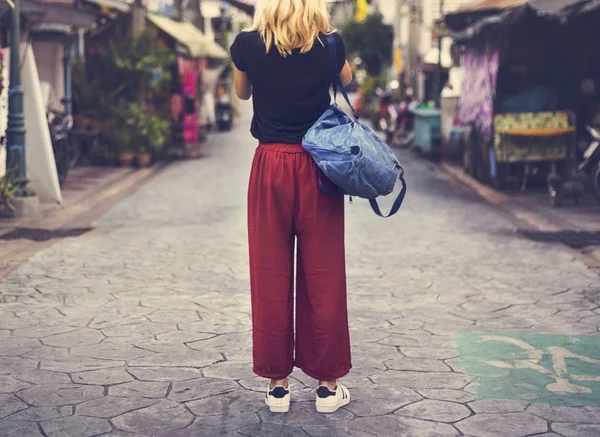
left=6, top=0, right=33, bottom=197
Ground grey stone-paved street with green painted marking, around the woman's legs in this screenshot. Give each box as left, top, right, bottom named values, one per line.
left=0, top=100, right=600, bottom=437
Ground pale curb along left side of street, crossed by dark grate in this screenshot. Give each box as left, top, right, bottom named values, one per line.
left=0, top=163, right=170, bottom=279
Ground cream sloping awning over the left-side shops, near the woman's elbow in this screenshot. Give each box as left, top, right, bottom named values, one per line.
left=147, top=13, right=229, bottom=59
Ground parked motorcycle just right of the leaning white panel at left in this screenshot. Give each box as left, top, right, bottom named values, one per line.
left=47, top=110, right=79, bottom=186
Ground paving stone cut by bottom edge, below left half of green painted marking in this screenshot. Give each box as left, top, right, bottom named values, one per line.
left=456, top=413, right=548, bottom=437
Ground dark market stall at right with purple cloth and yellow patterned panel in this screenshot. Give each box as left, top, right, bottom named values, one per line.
left=445, top=0, right=596, bottom=200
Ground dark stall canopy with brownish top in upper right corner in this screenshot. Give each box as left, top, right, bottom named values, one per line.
left=443, top=0, right=600, bottom=40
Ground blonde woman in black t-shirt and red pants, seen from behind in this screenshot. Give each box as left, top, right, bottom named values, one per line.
left=231, top=0, right=352, bottom=413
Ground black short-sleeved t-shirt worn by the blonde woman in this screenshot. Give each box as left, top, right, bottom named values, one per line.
left=230, top=32, right=346, bottom=144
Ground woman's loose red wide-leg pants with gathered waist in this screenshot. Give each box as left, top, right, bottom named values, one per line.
left=248, top=144, right=352, bottom=381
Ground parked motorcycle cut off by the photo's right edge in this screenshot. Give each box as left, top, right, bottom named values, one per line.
left=548, top=126, right=600, bottom=206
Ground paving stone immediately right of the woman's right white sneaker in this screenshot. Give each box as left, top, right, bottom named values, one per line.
left=342, top=385, right=421, bottom=416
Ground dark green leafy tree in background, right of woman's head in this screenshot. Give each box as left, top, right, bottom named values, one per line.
left=342, top=14, right=394, bottom=76
